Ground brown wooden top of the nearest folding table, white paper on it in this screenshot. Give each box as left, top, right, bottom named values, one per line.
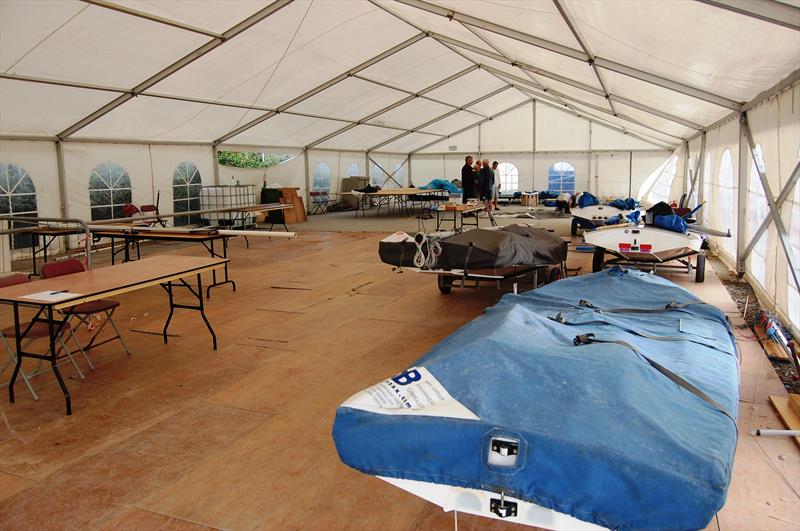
left=0, top=255, right=229, bottom=309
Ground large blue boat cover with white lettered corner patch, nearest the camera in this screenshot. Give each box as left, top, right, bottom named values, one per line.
left=333, top=268, right=739, bottom=529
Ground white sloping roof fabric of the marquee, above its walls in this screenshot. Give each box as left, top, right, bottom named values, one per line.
left=0, top=0, right=800, bottom=152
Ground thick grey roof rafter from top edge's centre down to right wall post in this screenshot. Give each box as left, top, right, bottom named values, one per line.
left=396, top=0, right=741, bottom=111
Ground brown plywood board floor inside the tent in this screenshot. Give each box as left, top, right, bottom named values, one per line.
left=0, top=232, right=800, bottom=531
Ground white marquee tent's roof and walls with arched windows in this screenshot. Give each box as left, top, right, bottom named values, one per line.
left=0, top=0, right=800, bottom=325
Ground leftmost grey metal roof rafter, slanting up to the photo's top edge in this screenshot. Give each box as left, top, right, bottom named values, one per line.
left=57, top=0, right=293, bottom=140
